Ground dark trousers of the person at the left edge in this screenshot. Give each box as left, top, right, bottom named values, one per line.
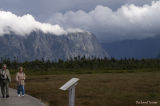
left=0, top=80, right=9, bottom=97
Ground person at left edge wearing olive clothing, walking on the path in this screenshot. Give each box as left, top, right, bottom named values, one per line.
left=0, top=64, right=11, bottom=98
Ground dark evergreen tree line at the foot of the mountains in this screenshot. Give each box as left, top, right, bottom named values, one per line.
left=0, top=56, right=160, bottom=74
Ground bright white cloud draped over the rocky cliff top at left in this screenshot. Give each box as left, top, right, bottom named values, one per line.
left=0, top=11, right=82, bottom=36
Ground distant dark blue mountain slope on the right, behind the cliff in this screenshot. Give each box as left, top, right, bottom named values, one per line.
left=101, top=36, right=160, bottom=59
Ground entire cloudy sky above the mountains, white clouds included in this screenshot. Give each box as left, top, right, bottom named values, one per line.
left=0, top=0, right=160, bottom=42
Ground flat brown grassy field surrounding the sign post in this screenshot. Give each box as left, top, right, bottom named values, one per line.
left=11, top=72, right=160, bottom=106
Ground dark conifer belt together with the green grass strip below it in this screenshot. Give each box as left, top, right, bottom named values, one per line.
left=0, top=57, right=160, bottom=75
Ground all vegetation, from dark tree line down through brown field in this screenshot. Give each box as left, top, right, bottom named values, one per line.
left=0, top=57, right=160, bottom=106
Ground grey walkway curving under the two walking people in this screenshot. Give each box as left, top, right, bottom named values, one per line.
left=0, top=89, right=46, bottom=106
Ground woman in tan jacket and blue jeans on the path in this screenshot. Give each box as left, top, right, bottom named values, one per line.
left=16, top=67, right=25, bottom=96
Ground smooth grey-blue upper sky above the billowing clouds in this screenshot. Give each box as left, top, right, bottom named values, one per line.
left=0, top=0, right=157, bottom=21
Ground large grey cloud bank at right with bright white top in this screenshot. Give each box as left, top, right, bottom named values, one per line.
left=48, top=1, right=160, bottom=42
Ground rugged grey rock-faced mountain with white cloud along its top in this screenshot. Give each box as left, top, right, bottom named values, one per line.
left=0, top=31, right=109, bottom=61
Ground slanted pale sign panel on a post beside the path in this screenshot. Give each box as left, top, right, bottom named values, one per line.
left=60, top=78, right=79, bottom=106
